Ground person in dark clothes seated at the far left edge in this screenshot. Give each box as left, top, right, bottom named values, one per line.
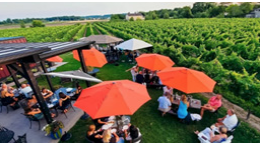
left=1, top=84, right=18, bottom=107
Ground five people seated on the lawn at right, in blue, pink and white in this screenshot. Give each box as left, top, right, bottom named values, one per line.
left=158, top=86, right=238, bottom=142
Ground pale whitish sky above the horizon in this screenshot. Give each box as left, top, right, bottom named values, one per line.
left=0, top=2, right=193, bottom=21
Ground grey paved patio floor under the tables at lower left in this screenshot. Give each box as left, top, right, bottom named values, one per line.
left=0, top=102, right=83, bottom=143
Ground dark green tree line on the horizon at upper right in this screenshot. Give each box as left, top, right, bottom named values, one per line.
left=111, top=2, right=260, bottom=20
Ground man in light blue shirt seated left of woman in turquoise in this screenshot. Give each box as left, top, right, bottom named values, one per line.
left=158, top=92, right=171, bottom=116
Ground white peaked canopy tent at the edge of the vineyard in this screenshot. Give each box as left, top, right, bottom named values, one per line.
left=115, top=38, right=152, bottom=50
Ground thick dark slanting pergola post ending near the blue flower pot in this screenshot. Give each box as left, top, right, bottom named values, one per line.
left=22, top=63, right=53, bottom=124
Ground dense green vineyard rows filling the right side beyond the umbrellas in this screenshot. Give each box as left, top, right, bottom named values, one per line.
left=95, top=19, right=260, bottom=116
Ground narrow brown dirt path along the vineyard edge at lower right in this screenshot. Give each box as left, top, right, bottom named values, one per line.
left=201, top=93, right=260, bottom=131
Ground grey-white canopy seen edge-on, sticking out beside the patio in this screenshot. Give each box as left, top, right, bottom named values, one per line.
left=42, top=70, right=102, bottom=83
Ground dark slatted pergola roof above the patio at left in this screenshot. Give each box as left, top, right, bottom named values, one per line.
left=0, top=41, right=95, bottom=64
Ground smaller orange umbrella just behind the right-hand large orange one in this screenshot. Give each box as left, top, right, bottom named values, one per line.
left=136, top=54, right=175, bottom=71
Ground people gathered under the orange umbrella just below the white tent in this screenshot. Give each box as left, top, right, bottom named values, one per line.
left=126, top=65, right=162, bottom=85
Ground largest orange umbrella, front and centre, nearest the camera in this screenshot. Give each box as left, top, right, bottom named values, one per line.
left=74, top=80, right=151, bottom=119
